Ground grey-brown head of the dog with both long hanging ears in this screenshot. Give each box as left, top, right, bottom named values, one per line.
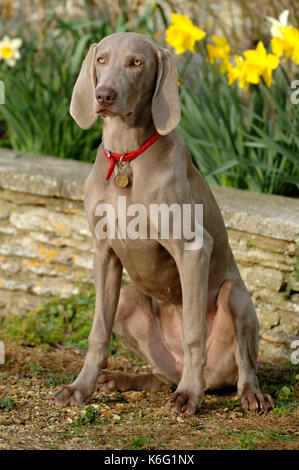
left=70, top=33, right=181, bottom=135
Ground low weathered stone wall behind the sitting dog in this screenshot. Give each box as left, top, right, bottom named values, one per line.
left=0, top=149, right=299, bottom=358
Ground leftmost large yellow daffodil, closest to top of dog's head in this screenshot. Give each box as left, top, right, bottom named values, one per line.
left=166, top=13, right=206, bottom=54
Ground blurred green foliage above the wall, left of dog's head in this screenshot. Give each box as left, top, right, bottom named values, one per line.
left=0, top=29, right=101, bottom=161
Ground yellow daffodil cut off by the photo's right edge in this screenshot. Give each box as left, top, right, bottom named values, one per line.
left=271, top=26, right=299, bottom=65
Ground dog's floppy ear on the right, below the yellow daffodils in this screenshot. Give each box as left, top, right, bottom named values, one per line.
left=152, top=46, right=181, bottom=135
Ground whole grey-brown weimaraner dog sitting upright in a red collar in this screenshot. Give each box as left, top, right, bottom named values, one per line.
left=51, top=33, right=273, bottom=415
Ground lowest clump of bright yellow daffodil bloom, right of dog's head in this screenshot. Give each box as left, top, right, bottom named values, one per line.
left=227, top=42, right=279, bottom=90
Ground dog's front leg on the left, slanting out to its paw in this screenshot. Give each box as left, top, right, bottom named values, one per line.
left=51, top=246, right=122, bottom=406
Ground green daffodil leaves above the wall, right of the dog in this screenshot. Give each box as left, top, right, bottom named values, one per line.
left=178, top=60, right=299, bottom=195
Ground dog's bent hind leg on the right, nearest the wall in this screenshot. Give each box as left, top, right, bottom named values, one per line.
left=205, top=281, right=273, bottom=411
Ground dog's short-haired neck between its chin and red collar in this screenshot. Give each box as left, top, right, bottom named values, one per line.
left=102, top=100, right=156, bottom=153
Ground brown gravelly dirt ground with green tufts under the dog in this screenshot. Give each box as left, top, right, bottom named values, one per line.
left=0, top=345, right=299, bottom=450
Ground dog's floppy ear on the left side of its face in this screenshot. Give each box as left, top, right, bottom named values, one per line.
left=70, top=43, right=98, bottom=129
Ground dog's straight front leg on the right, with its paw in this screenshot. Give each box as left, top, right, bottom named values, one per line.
left=164, top=230, right=213, bottom=415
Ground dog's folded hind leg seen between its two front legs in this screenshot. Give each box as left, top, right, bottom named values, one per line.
left=98, top=285, right=182, bottom=391
